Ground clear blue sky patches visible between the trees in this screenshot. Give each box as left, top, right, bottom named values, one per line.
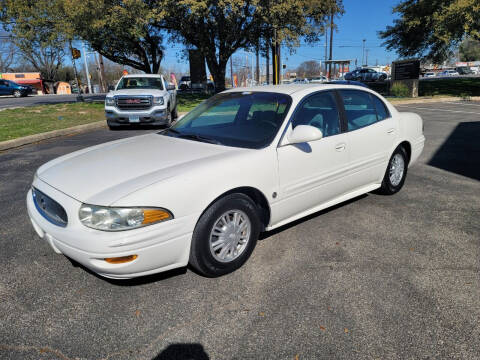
left=162, top=0, right=399, bottom=72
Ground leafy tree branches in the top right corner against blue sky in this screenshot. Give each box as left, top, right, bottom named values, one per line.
left=379, top=0, right=480, bottom=63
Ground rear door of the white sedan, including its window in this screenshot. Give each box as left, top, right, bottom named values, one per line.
left=339, top=90, right=398, bottom=190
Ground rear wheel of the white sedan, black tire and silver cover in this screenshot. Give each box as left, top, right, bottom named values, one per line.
left=378, top=146, right=408, bottom=195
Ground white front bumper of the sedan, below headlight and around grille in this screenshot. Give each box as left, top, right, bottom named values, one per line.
left=27, top=179, right=196, bottom=279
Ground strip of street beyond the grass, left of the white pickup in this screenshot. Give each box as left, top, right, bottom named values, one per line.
left=0, top=94, right=105, bottom=110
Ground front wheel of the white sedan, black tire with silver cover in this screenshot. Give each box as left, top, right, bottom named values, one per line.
left=189, top=194, right=261, bottom=277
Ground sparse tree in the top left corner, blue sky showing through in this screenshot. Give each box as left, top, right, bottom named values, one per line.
left=0, top=0, right=66, bottom=80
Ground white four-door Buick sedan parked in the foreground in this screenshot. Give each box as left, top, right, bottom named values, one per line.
left=27, top=84, right=425, bottom=279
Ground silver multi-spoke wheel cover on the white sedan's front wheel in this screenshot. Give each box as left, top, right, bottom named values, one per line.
left=209, top=210, right=252, bottom=263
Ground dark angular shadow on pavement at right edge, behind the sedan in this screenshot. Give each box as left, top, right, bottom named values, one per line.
left=428, top=122, right=480, bottom=181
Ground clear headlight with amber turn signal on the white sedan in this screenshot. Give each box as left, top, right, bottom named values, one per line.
left=78, top=204, right=173, bottom=231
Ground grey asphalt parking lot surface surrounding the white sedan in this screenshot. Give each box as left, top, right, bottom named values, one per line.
left=0, top=101, right=480, bottom=360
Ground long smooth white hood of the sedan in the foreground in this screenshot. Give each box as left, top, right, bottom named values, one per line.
left=36, top=134, right=244, bottom=205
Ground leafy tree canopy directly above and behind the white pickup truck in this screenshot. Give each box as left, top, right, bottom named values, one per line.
left=62, top=0, right=164, bottom=74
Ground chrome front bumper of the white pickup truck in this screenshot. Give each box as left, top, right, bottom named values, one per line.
left=105, top=106, right=168, bottom=126
